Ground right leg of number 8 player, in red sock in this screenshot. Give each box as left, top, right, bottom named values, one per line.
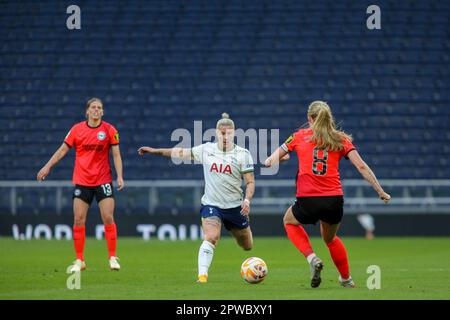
left=320, top=221, right=355, bottom=288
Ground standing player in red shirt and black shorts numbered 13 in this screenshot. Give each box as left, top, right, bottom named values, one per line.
left=37, top=98, right=124, bottom=272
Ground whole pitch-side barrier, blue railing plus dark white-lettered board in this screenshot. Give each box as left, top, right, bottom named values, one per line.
left=0, top=180, right=450, bottom=240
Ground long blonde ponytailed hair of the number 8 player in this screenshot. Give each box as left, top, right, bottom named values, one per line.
left=308, top=101, right=352, bottom=151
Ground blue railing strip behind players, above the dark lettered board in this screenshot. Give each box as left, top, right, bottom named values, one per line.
left=0, top=180, right=450, bottom=215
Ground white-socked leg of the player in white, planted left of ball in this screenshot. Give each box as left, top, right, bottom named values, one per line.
left=197, top=216, right=222, bottom=283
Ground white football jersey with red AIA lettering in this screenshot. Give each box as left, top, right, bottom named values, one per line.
left=191, top=142, right=254, bottom=209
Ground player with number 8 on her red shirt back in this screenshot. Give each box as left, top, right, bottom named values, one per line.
left=265, top=101, right=391, bottom=288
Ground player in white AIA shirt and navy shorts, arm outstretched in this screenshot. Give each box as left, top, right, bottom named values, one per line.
left=138, top=113, right=255, bottom=283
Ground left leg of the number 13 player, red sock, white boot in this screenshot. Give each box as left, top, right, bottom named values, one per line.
left=70, top=198, right=89, bottom=272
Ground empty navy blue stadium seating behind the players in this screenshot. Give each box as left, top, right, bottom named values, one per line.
left=0, top=0, right=450, bottom=181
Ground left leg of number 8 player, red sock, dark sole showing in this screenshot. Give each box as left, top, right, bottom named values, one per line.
left=283, top=207, right=323, bottom=288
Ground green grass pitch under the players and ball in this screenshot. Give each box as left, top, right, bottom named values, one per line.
left=0, top=237, right=450, bottom=300
